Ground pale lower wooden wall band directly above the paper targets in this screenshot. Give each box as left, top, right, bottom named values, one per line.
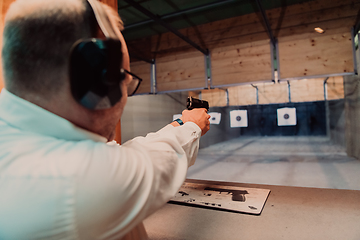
left=193, top=76, right=344, bottom=107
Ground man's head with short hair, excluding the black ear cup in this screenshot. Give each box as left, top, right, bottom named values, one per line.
left=2, top=0, right=131, bottom=141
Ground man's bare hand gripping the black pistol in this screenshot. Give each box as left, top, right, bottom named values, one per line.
left=172, top=108, right=210, bottom=136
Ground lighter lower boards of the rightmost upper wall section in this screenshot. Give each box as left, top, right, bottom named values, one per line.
left=279, top=33, right=353, bottom=79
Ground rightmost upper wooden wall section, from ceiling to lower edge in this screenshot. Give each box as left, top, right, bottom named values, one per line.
left=272, top=0, right=360, bottom=79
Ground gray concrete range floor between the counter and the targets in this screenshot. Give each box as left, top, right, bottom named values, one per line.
left=187, top=137, right=360, bottom=190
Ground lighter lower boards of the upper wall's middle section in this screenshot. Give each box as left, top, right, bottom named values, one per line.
left=211, top=42, right=272, bottom=86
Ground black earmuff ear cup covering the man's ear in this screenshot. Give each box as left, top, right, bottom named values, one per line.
left=69, top=38, right=125, bottom=110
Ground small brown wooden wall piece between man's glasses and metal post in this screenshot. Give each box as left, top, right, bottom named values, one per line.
left=130, top=62, right=151, bottom=94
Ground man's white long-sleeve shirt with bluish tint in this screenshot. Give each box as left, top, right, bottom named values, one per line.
left=0, top=90, right=201, bottom=240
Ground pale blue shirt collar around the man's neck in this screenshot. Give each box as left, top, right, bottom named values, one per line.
left=0, top=89, right=107, bottom=142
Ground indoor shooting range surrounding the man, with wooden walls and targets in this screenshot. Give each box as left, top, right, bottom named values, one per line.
left=0, top=0, right=360, bottom=240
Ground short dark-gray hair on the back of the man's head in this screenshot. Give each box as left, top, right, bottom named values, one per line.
left=2, top=0, right=97, bottom=95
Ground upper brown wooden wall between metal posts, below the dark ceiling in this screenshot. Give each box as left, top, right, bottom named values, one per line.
left=129, top=0, right=360, bottom=90
